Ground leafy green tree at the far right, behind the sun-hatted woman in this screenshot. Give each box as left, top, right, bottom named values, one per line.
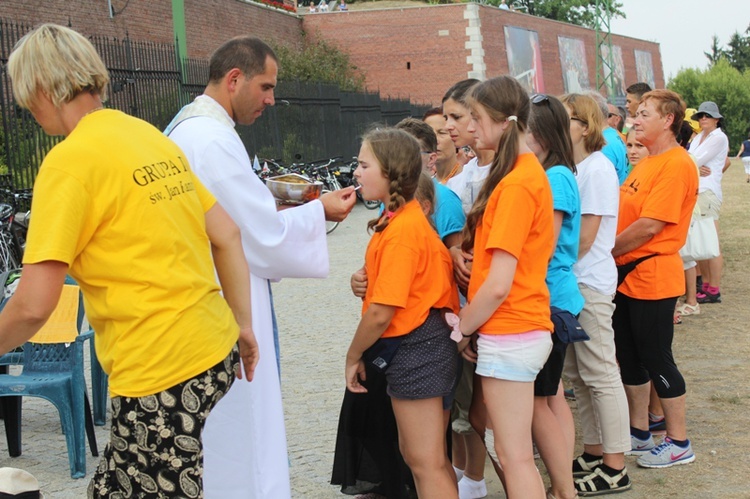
left=668, top=58, right=750, bottom=154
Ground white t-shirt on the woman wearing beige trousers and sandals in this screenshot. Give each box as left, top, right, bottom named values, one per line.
left=573, top=151, right=620, bottom=295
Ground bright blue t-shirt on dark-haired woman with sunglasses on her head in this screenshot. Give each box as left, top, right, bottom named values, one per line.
left=546, top=165, right=584, bottom=315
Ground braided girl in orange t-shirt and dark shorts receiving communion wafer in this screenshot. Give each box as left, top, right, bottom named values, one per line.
left=345, top=129, right=458, bottom=498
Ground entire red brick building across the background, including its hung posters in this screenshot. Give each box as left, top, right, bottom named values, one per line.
left=0, top=0, right=664, bottom=104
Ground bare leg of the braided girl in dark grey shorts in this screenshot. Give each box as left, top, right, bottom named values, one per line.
left=391, top=397, right=458, bottom=499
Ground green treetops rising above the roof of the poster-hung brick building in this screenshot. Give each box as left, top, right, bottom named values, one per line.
left=486, top=0, right=625, bottom=28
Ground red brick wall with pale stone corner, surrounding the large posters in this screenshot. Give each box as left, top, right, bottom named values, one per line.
left=303, top=4, right=664, bottom=104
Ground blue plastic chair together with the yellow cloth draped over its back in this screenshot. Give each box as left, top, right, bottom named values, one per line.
left=0, top=285, right=97, bottom=478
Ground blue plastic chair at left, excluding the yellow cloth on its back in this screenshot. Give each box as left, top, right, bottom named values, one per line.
left=0, top=282, right=97, bottom=478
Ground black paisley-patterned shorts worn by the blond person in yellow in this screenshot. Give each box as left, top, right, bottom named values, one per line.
left=88, top=346, right=239, bottom=499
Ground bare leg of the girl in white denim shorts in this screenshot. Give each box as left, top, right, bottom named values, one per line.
left=482, top=378, right=544, bottom=499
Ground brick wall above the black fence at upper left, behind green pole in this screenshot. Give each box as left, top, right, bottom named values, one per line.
left=0, top=0, right=302, bottom=58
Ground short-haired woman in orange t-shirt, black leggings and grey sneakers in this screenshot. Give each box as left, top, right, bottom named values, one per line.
left=612, top=90, right=698, bottom=468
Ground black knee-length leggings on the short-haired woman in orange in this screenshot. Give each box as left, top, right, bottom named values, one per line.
left=612, top=293, right=685, bottom=398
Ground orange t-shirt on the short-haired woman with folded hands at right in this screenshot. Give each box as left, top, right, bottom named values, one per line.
left=615, top=147, right=698, bottom=300
